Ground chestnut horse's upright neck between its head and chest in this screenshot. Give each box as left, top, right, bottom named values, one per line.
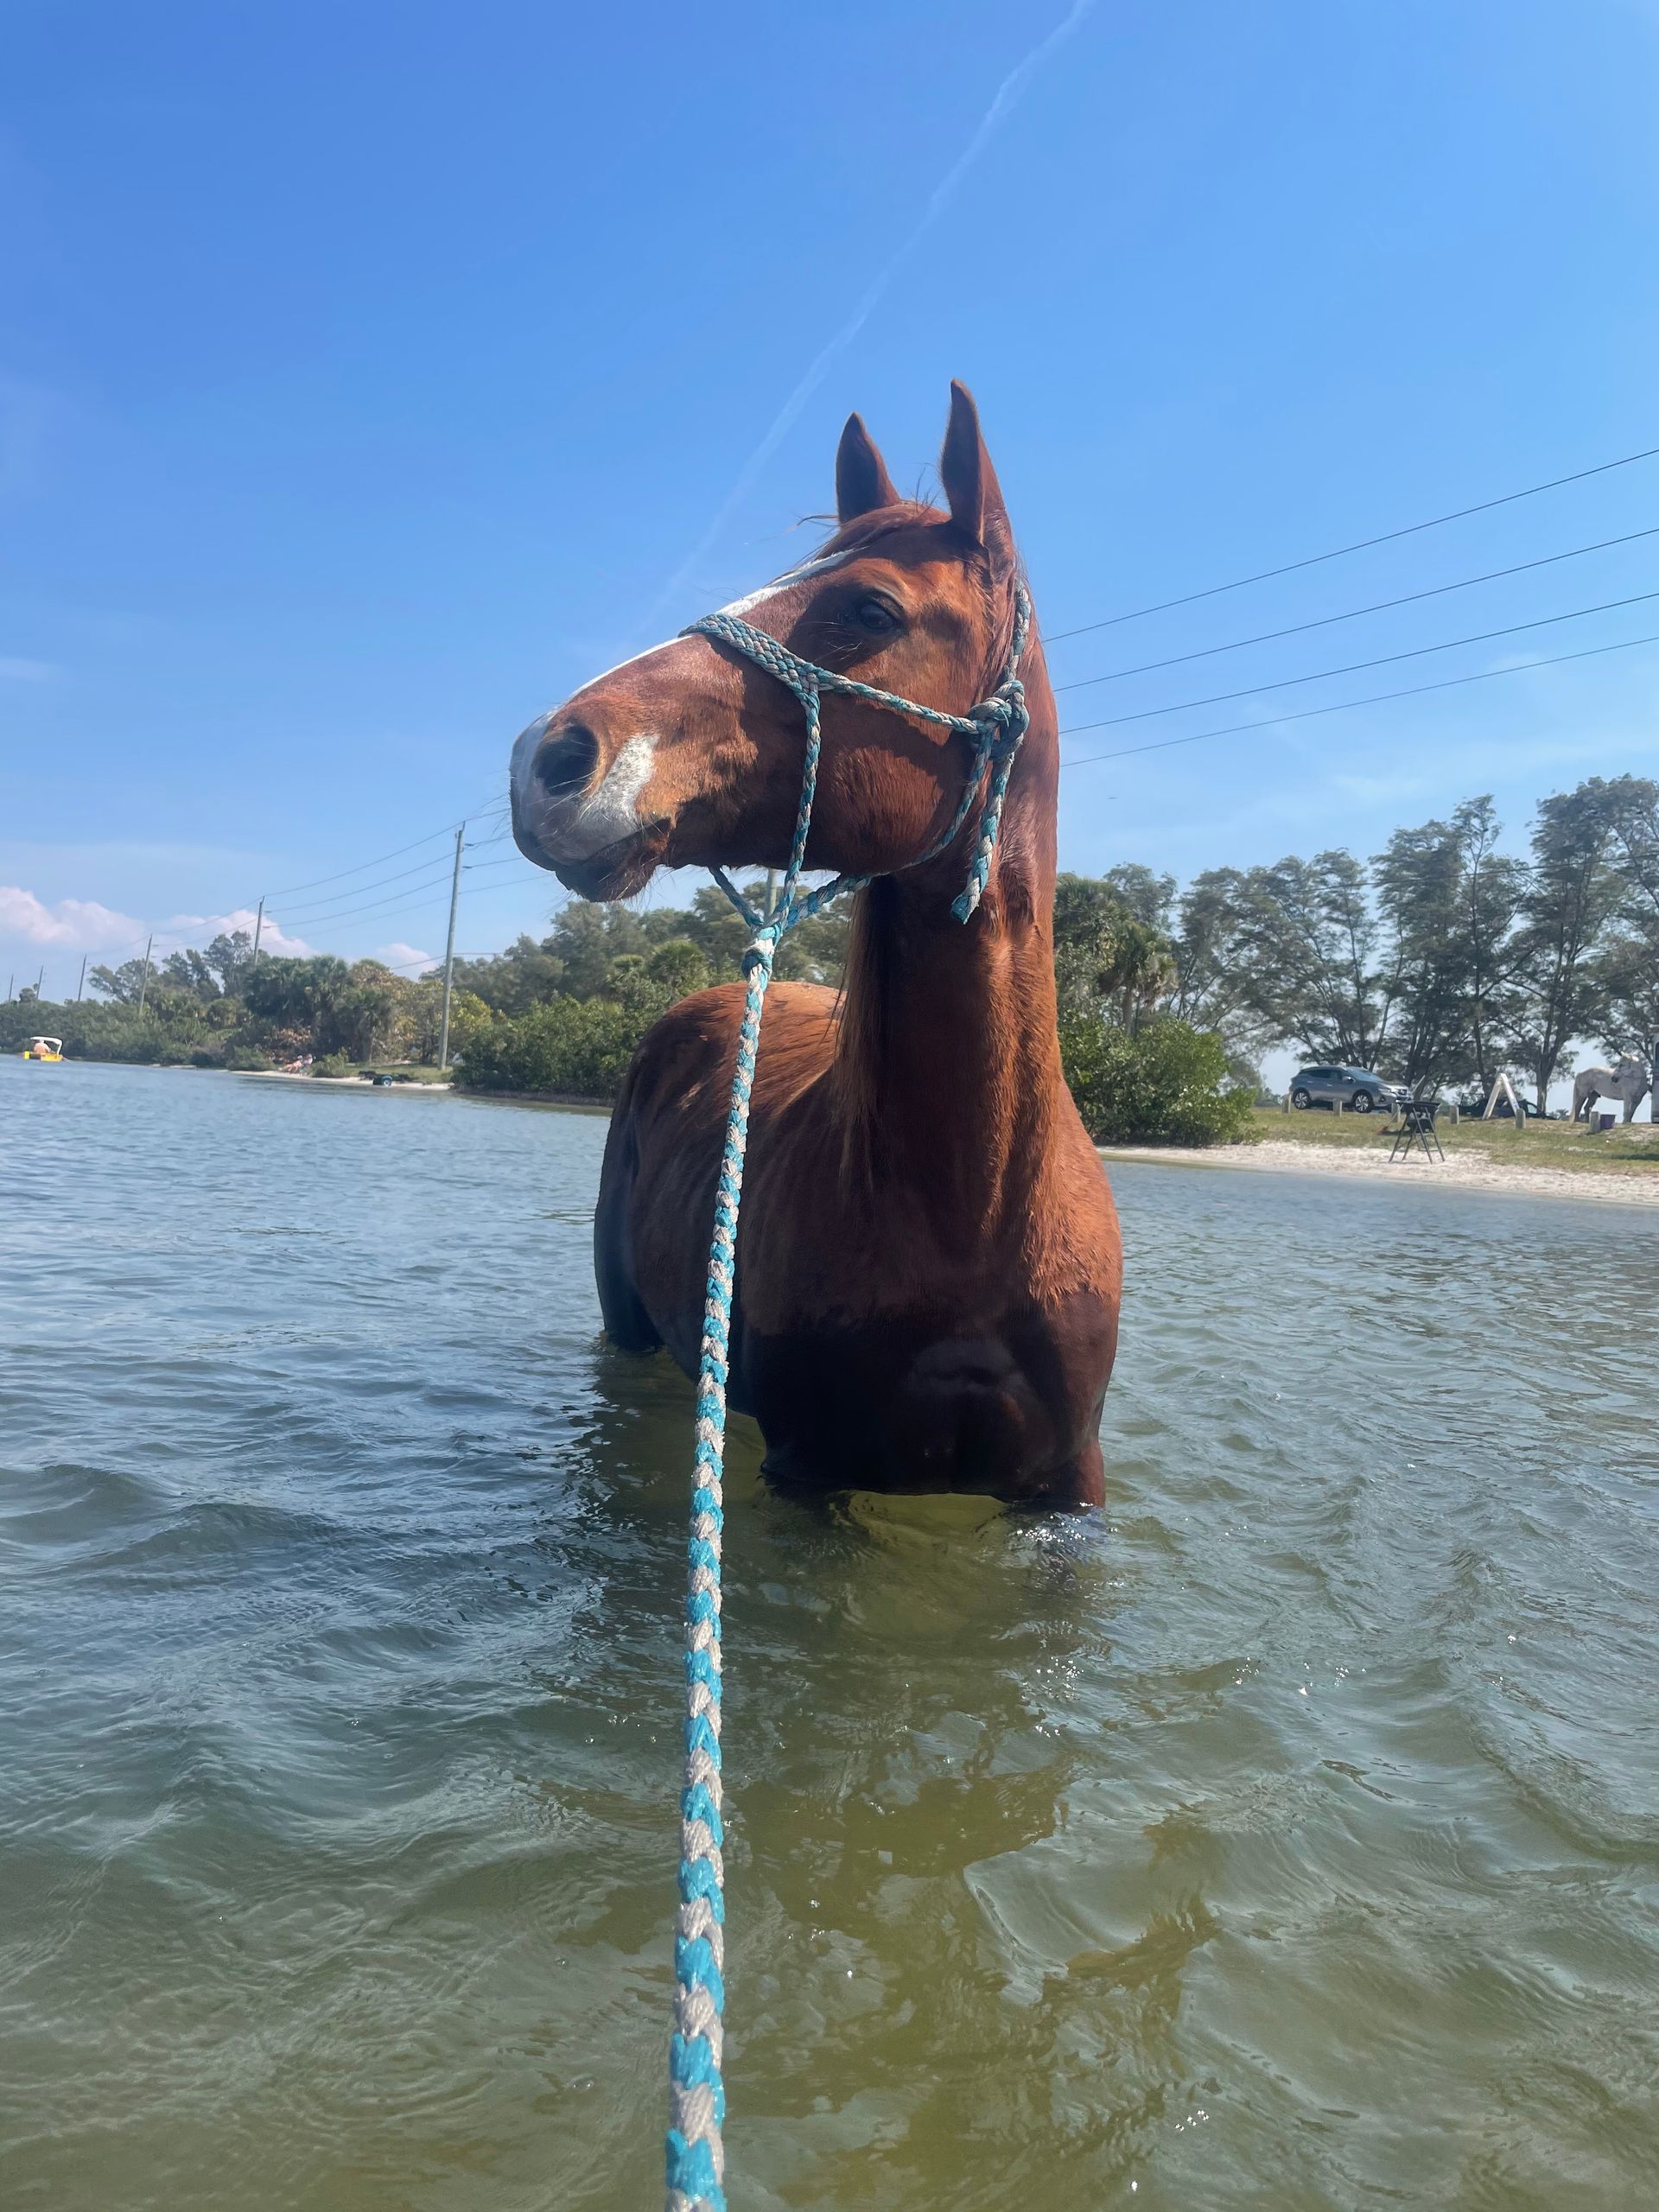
left=836, top=683, right=1062, bottom=1248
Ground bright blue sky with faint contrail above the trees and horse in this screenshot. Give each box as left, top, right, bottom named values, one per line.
left=0, top=0, right=1659, bottom=991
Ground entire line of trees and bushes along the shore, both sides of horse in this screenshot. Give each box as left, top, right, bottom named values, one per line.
left=0, top=777, right=1659, bottom=1141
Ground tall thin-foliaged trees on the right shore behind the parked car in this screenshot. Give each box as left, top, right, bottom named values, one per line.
left=1079, top=777, right=1659, bottom=1106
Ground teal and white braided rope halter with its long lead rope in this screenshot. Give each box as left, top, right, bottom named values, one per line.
left=668, top=584, right=1031, bottom=2212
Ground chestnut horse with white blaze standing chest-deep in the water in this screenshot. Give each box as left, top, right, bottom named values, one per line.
left=513, top=385, right=1122, bottom=1506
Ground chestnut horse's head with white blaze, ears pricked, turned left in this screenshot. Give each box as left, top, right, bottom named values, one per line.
left=513, top=385, right=1044, bottom=898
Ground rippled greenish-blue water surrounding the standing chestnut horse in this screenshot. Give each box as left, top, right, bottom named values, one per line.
left=0, top=1062, right=1659, bottom=2212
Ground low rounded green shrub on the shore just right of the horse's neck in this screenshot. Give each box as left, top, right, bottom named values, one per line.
left=1059, top=1013, right=1255, bottom=1144
